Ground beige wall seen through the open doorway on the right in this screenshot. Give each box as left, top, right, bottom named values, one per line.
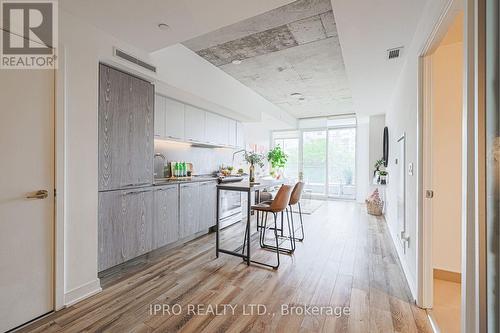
left=432, top=43, right=463, bottom=272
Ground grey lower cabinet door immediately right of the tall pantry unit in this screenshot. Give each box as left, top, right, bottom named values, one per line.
left=153, top=185, right=179, bottom=249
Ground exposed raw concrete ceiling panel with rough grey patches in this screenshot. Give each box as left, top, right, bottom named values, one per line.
left=183, top=0, right=355, bottom=118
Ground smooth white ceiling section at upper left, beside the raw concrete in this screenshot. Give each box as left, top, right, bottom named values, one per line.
left=59, top=0, right=293, bottom=52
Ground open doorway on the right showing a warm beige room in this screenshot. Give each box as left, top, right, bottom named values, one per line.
left=421, top=10, right=464, bottom=332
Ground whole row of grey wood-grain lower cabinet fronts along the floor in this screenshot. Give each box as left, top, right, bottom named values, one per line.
left=98, top=181, right=217, bottom=271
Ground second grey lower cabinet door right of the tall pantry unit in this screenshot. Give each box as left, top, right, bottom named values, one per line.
left=179, top=183, right=201, bottom=239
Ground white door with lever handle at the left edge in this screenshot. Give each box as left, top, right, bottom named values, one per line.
left=0, top=69, right=54, bottom=332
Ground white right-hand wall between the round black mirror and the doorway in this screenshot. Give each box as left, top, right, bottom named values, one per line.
left=386, top=0, right=454, bottom=297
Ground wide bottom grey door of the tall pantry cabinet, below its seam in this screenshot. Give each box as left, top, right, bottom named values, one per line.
left=98, top=187, right=153, bottom=271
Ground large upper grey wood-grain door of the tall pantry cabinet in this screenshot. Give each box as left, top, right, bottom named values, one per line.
left=99, top=64, right=154, bottom=191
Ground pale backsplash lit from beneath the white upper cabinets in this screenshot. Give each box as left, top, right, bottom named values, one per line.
left=154, top=140, right=248, bottom=175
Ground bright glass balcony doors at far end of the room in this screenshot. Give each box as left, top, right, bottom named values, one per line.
left=272, top=117, right=356, bottom=199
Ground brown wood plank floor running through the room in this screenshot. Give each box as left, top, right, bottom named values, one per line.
left=18, top=201, right=431, bottom=333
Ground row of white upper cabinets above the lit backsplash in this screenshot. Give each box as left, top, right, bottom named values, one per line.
left=154, top=95, right=244, bottom=148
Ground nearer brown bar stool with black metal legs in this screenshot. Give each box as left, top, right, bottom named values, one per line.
left=243, top=185, right=295, bottom=269
